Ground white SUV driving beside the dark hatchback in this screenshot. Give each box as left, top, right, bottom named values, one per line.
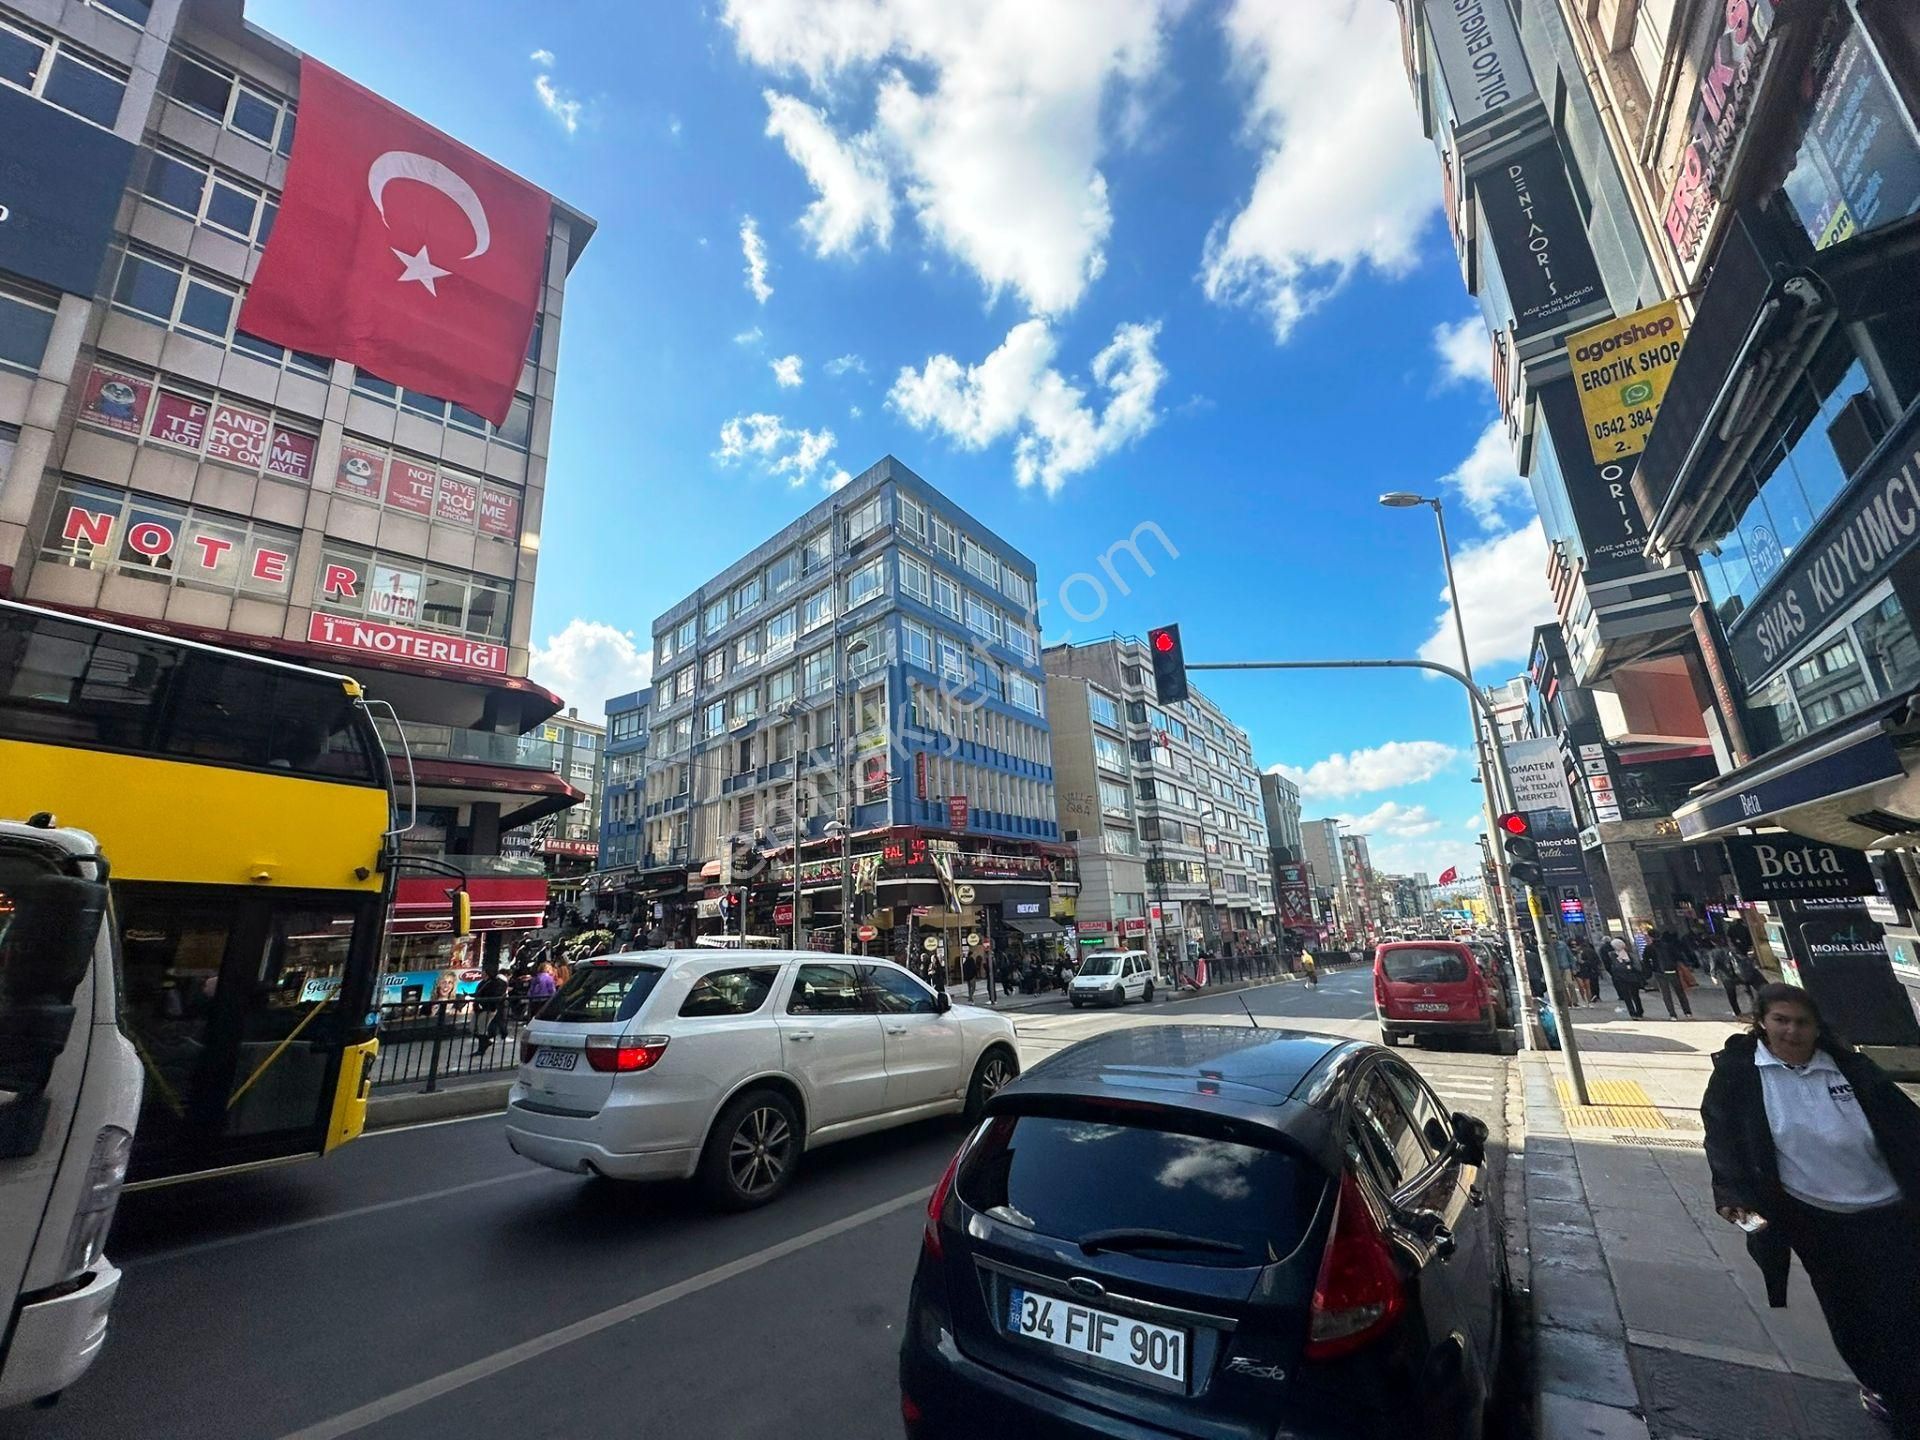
left=507, top=950, right=1020, bottom=1210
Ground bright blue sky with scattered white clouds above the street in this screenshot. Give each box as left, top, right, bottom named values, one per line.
left=248, top=0, right=1551, bottom=874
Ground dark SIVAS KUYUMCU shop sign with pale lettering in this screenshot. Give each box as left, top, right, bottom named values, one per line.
left=1728, top=411, right=1920, bottom=689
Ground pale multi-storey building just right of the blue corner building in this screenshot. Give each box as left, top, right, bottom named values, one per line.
left=1043, top=636, right=1275, bottom=950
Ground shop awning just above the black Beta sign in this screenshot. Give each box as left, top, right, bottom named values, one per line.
left=1674, top=695, right=1920, bottom=849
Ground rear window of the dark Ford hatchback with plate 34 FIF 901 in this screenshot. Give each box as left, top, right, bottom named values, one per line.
left=956, top=1116, right=1325, bottom=1267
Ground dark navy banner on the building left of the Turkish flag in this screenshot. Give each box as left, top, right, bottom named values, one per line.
left=0, top=86, right=132, bottom=296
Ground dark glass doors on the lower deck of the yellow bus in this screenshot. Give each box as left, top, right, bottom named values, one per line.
left=115, top=883, right=378, bottom=1181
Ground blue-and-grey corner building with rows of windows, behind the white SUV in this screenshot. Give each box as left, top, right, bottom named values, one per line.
left=622, top=455, right=1073, bottom=954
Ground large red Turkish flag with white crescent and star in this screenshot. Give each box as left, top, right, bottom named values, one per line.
left=240, top=58, right=553, bottom=424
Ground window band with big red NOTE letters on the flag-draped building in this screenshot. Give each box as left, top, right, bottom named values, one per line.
left=40, top=480, right=300, bottom=601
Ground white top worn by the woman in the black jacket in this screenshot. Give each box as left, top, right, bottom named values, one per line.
left=1753, top=1044, right=1901, bottom=1210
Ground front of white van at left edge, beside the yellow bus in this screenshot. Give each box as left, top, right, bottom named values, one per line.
left=0, top=816, right=140, bottom=1409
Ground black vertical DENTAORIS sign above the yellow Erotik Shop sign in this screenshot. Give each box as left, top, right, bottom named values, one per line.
left=1475, top=134, right=1607, bottom=344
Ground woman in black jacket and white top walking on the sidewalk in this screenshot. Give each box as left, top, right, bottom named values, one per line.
left=1699, top=985, right=1920, bottom=1440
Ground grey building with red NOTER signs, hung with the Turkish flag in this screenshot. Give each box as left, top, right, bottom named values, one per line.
left=0, top=0, right=593, bottom=963
